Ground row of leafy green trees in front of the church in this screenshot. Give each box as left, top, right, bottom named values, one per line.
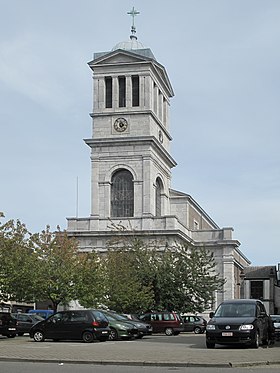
left=0, top=215, right=224, bottom=313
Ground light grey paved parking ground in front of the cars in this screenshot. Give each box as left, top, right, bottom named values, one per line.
left=0, top=334, right=280, bottom=368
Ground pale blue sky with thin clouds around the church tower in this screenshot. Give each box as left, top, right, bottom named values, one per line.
left=0, top=0, right=280, bottom=265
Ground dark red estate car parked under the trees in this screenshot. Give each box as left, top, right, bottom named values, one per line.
left=139, top=311, right=184, bottom=335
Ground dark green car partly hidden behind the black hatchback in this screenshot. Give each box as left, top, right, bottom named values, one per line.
left=98, top=310, right=138, bottom=340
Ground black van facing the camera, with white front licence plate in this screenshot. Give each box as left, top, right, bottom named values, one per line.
left=206, top=299, right=273, bottom=348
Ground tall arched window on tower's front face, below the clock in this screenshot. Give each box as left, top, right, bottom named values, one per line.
left=111, top=170, right=134, bottom=217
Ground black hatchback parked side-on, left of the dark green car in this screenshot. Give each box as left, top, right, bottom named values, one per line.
left=29, top=310, right=110, bottom=343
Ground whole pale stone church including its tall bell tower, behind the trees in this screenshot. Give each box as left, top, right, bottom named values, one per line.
left=67, top=8, right=250, bottom=308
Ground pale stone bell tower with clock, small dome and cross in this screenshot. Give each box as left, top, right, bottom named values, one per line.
left=85, top=8, right=176, bottom=220
